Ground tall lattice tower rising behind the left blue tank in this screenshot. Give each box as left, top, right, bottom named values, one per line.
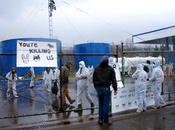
left=48, top=0, right=56, bottom=39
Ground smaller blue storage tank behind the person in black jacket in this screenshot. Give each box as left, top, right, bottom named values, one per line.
left=73, top=43, right=112, bottom=69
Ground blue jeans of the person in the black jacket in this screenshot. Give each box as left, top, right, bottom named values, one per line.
left=95, top=86, right=111, bottom=122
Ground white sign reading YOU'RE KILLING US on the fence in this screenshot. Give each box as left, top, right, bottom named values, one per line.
left=16, top=40, right=57, bottom=67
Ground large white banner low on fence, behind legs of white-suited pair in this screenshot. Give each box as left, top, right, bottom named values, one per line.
left=111, top=85, right=154, bottom=113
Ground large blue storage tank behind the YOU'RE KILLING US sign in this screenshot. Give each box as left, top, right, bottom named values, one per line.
left=0, top=38, right=61, bottom=76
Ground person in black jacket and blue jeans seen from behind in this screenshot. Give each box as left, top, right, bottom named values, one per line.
left=93, top=57, right=117, bottom=125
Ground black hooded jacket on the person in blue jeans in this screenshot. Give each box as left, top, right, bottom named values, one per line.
left=93, top=58, right=117, bottom=90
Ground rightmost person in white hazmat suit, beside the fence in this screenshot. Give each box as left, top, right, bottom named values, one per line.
left=149, top=60, right=166, bottom=108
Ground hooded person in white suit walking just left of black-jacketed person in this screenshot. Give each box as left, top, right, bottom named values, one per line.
left=76, top=61, right=94, bottom=110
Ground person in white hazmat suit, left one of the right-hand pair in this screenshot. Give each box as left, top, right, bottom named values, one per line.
left=132, top=64, right=148, bottom=112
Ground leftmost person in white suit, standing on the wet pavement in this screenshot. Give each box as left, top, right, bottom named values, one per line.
left=6, top=67, right=18, bottom=98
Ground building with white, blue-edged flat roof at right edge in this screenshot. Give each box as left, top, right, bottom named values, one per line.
left=132, top=26, right=175, bottom=68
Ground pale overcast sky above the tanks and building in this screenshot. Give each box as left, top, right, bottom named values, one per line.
left=0, top=0, right=175, bottom=46
